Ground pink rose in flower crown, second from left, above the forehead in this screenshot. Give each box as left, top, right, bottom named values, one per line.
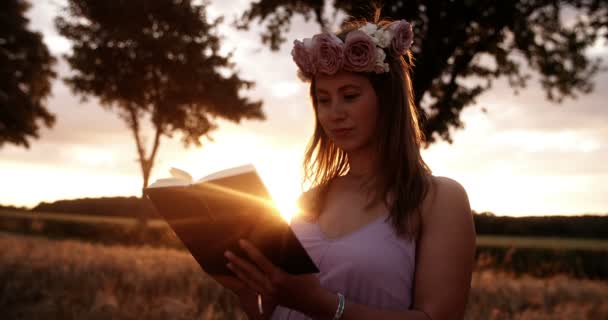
left=312, top=32, right=344, bottom=75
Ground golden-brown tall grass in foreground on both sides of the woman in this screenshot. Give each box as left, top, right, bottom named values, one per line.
left=0, top=234, right=608, bottom=320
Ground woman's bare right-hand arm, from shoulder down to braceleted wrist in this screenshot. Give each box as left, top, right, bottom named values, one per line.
left=309, top=177, right=475, bottom=320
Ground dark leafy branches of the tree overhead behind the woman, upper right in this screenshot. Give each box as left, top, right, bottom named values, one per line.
left=236, top=0, right=608, bottom=147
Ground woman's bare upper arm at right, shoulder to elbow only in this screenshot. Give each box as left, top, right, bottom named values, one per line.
left=413, top=177, right=476, bottom=320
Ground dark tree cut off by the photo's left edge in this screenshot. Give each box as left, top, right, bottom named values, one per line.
left=0, top=0, right=56, bottom=148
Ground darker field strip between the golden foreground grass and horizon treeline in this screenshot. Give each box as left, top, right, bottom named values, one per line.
left=0, top=210, right=608, bottom=281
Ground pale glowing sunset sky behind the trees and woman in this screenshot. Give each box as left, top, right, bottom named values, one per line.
left=0, top=0, right=608, bottom=216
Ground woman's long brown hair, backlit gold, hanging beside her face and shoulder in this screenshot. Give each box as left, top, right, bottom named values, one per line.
left=301, top=11, right=433, bottom=239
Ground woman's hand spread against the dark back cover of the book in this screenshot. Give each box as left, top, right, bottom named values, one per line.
left=225, top=240, right=325, bottom=314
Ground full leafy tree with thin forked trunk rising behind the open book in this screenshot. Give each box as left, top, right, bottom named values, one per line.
left=55, top=0, right=264, bottom=191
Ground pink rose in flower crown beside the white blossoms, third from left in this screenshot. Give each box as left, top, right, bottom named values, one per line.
left=344, top=30, right=376, bottom=72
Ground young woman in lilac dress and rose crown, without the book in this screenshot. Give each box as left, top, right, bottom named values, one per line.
left=218, top=12, right=475, bottom=320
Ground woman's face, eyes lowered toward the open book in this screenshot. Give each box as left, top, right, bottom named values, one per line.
left=314, top=71, right=378, bottom=152
